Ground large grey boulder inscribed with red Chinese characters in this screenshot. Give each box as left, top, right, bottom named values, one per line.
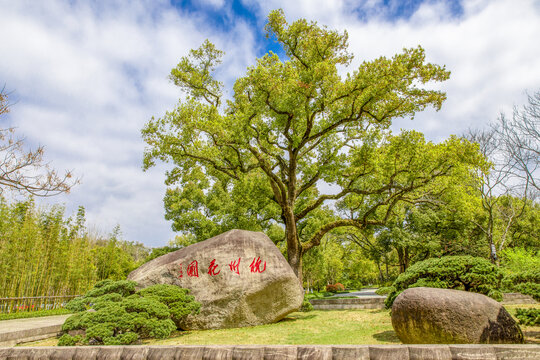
left=128, top=230, right=304, bottom=330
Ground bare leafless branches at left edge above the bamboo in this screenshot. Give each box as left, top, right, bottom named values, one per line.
left=0, top=89, right=78, bottom=196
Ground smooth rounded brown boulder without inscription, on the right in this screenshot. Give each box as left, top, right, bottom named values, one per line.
left=392, top=287, right=523, bottom=344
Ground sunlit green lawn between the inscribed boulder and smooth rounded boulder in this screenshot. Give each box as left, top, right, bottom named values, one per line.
left=148, top=310, right=399, bottom=345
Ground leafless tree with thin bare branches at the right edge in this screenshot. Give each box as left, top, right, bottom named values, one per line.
left=466, top=92, right=540, bottom=263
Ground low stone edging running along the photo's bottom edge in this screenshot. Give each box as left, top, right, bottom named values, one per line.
left=0, top=345, right=540, bottom=360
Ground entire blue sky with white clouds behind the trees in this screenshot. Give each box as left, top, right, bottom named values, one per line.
left=0, top=0, right=540, bottom=247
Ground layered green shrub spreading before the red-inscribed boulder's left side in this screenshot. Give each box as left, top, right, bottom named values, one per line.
left=59, top=280, right=200, bottom=346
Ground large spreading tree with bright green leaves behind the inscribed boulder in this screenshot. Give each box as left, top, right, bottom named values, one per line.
left=142, top=10, right=475, bottom=279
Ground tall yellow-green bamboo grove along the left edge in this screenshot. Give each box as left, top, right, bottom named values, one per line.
left=0, top=199, right=148, bottom=297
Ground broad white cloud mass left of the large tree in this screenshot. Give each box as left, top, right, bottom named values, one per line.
left=0, top=1, right=255, bottom=246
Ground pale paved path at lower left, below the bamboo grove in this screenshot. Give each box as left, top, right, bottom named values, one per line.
left=0, top=314, right=70, bottom=346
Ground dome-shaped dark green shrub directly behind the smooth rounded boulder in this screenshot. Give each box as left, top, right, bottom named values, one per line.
left=385, top=256, right=502, bottom=308
